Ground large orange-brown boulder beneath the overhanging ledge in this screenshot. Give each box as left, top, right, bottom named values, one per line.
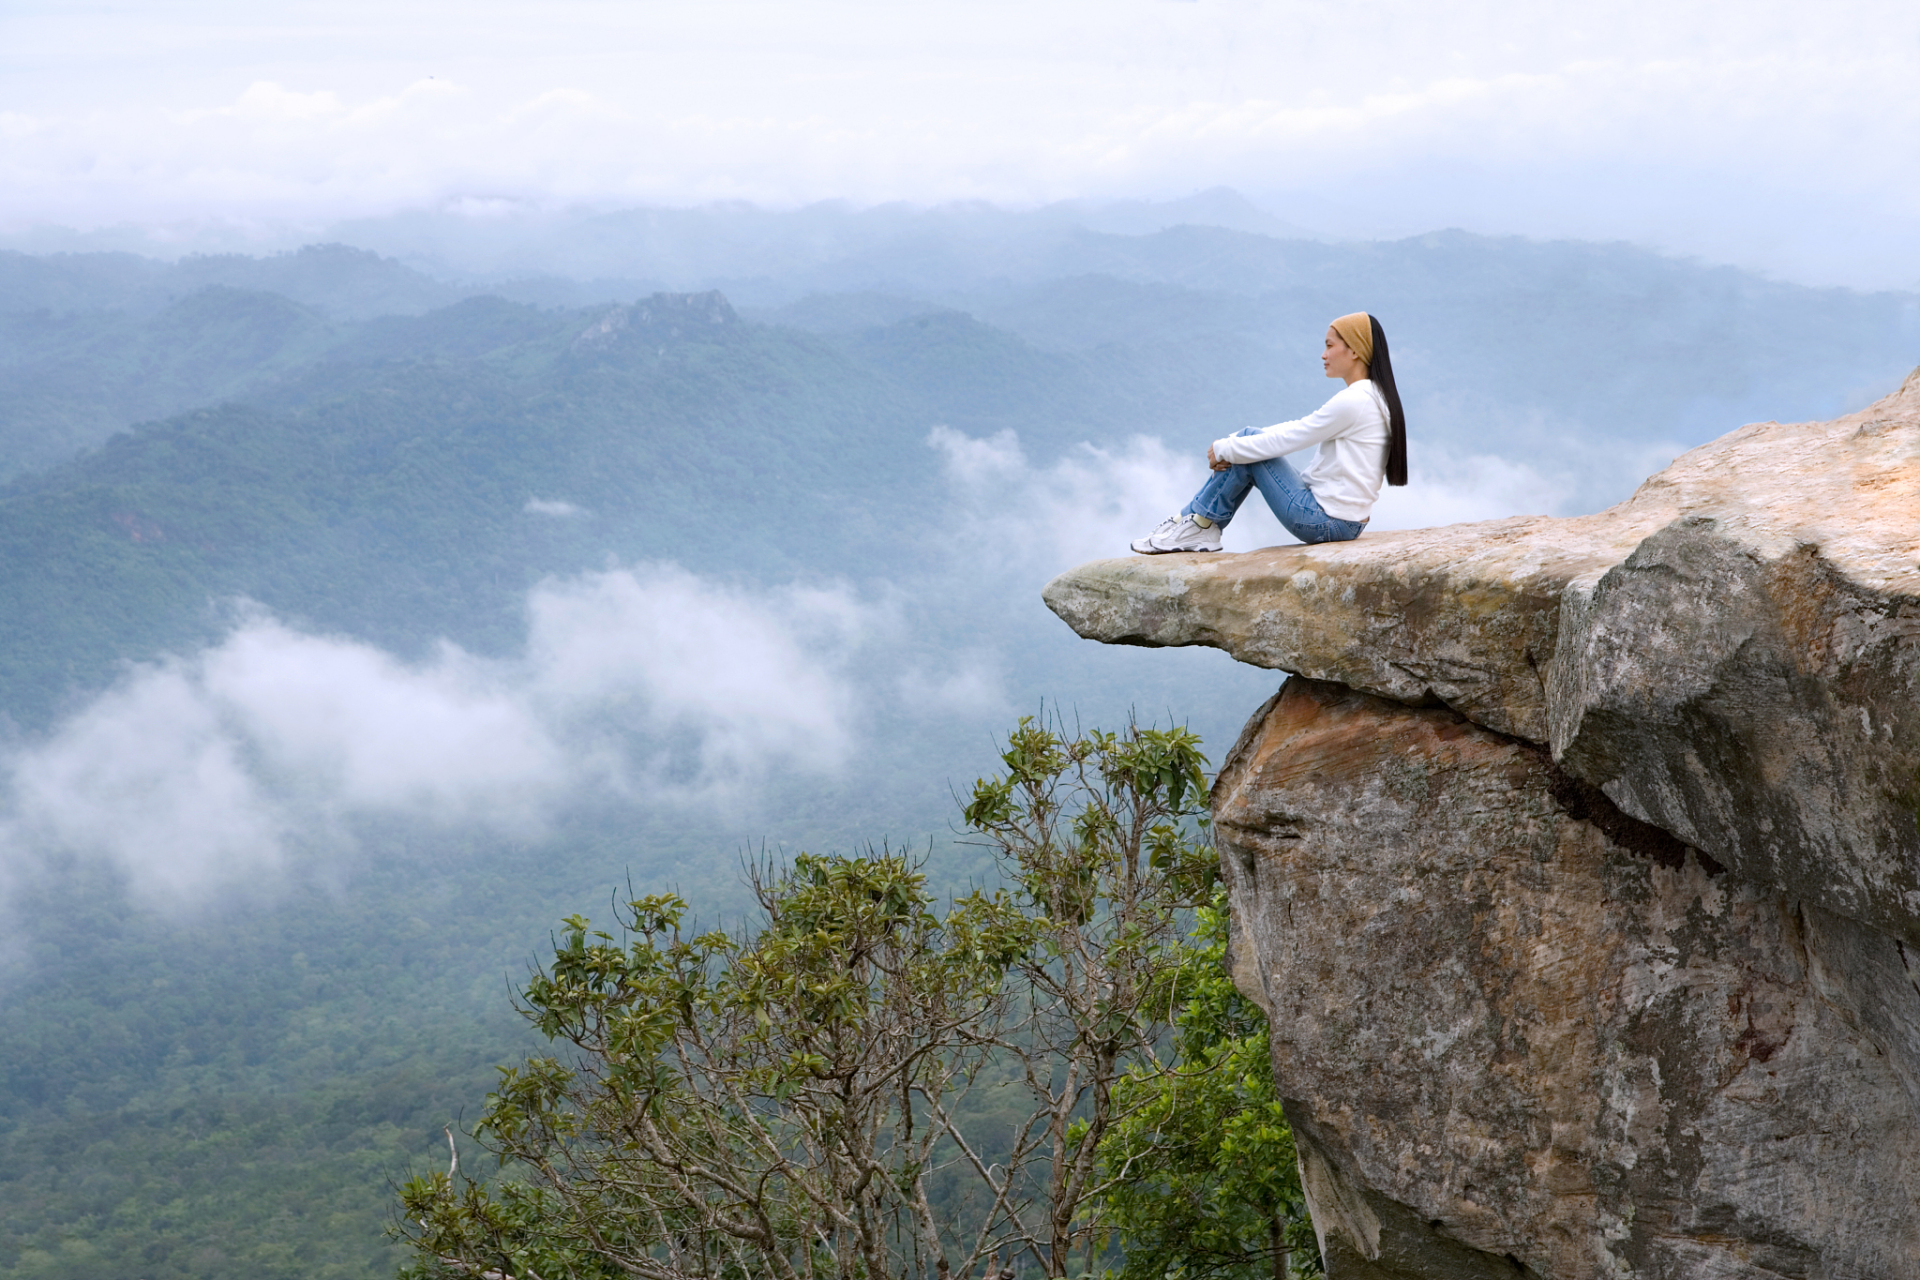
left=1215, top=679, right=1920, bottom=1280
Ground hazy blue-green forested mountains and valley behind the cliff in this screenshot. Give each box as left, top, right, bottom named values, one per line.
left=0, top=211, right=1920, bottom=1280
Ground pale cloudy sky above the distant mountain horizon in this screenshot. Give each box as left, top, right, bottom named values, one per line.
left=0, top=0, right=1920, bottom=288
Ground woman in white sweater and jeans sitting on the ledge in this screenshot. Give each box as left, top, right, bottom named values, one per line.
left=1133, top=311, right=1407, bottom=555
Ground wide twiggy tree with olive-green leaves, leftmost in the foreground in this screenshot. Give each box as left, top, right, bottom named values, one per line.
left=405, top=854, right=995, bottom=1280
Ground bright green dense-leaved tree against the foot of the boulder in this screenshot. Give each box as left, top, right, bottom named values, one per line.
left=1100, top=892, right=1321, bottom=1280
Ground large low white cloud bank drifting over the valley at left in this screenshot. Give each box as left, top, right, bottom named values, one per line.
left=0, top=564, right=883, bottom=902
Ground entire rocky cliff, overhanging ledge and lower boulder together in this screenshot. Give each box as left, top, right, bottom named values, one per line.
left=1046, top=364, right=1920, bottom=1280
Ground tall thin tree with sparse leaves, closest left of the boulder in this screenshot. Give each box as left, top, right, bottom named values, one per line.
left=948, top=718, right=1215, bottom=1276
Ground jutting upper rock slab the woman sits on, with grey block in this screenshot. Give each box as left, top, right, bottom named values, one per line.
left=1044, top=370, right=1920, bottom=944
